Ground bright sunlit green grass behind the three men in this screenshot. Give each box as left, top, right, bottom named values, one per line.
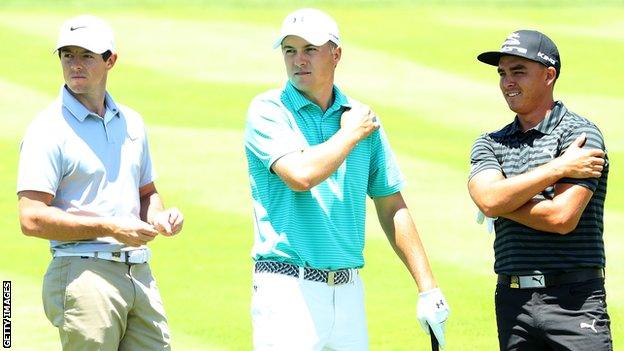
left=0, top=0, right=624, bottom=350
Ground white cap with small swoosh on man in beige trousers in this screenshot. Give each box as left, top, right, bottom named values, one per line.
left=55, top=15, right=115, bottom=54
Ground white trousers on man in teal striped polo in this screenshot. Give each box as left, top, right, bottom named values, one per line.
left=251, top=273, right=368, bottom=351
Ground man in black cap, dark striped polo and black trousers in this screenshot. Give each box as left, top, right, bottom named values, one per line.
left=468, top=30, right=612, bottom=351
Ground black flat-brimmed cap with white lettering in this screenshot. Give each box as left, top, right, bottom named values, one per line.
left=477, top=30, right=561, bottom=77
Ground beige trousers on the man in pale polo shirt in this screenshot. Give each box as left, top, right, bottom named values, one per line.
left=43, top=257, right=171, bottom=351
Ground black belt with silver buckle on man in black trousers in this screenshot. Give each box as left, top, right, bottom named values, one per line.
left=498, top=268, right=604, bottom=289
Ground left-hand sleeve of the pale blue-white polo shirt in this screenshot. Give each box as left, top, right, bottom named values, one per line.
left=17, top=123, right=63, bottom=196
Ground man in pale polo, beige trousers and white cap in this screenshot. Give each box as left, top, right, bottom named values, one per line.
left=17, top=15, right=183, bottom=351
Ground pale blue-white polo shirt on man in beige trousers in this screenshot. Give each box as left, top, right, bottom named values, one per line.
left=17, top=86, right=155, bottom=252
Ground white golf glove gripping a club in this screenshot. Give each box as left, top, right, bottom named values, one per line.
left=416, top=288, right=451, bottom=348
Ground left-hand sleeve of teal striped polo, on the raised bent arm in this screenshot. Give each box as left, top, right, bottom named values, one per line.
left=245, top=98, right=307, bottom=170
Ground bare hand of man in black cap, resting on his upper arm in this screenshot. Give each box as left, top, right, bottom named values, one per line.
left=552, top=133, right=605, bottom=178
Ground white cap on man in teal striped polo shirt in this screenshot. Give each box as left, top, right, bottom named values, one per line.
left=273, top=8, right=340, bottom=49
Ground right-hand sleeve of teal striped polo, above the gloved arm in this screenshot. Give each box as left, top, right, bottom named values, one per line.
left=367, top=123, right=405, bottom=197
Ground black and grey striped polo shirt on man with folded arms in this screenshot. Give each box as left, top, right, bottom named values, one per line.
left=470, top=101, right=609, bottom=274
